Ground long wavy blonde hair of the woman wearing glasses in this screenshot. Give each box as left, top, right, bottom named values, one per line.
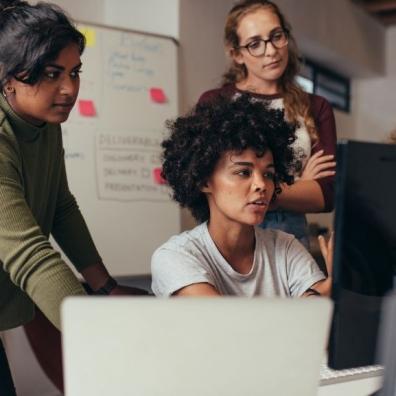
left=222, top=0, right=319, bottom=144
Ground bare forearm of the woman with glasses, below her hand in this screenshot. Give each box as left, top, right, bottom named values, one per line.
left=274, top=180, right=325, bottom=213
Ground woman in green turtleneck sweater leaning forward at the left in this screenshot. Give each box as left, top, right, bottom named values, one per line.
left=0, top=0, right=142, bottom=387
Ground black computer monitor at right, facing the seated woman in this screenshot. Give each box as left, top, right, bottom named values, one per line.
left=328, top=141, right=396, bottom=369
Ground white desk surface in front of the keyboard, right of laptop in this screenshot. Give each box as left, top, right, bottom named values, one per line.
left=318, top=375, right=382, bottom=396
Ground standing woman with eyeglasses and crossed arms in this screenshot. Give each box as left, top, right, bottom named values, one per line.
left=199, top=0, right=336, bottom=247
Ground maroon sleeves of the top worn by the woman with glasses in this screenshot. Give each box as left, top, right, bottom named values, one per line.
left=198, top=84, right=337, bottom=212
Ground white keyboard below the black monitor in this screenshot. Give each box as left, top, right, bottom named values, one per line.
left=320, top=364, right=384, bottom=385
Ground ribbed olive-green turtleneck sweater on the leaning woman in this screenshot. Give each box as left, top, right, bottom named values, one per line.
left=0, top=94, right=101, bottom=330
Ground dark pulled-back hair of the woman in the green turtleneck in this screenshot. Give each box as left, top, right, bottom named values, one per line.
left=0, top=0, right=85, bottom=88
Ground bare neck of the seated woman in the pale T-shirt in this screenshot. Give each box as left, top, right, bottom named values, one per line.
left=208, top=219, right=256, bottom=273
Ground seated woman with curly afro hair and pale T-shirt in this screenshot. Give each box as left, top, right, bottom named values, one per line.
left=151, top=95, right=331, bottom=297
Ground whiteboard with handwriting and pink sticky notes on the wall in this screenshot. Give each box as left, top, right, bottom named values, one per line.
left=62, top=24, right=180, bottom=276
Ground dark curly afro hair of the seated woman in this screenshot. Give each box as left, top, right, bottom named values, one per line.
left=162, top=94, right=295, bottom=222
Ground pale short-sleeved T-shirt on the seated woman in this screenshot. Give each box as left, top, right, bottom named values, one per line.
left=151, top=223, right=325, bottom=297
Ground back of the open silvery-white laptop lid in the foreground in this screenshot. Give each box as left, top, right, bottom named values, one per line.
left=62, top=297, right=332, bottom=396
